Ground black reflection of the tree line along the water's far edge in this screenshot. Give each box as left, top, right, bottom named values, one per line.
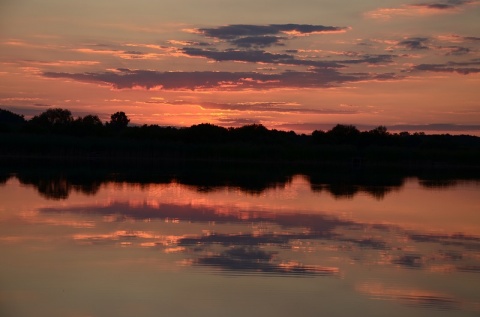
left=0, top=164, right=480, bottom=199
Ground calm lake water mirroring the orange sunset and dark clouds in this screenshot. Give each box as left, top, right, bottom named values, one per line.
left=0, top=169, right=480, bottom=317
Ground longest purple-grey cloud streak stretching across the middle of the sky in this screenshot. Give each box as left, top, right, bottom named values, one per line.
left=43, top=69, right=376, bottom=90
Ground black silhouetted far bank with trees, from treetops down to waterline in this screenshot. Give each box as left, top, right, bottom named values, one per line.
left=0, top=108, right=480, bottom=166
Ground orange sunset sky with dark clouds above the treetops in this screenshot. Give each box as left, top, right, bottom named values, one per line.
left=0, top=0, right=480, bottom=135
